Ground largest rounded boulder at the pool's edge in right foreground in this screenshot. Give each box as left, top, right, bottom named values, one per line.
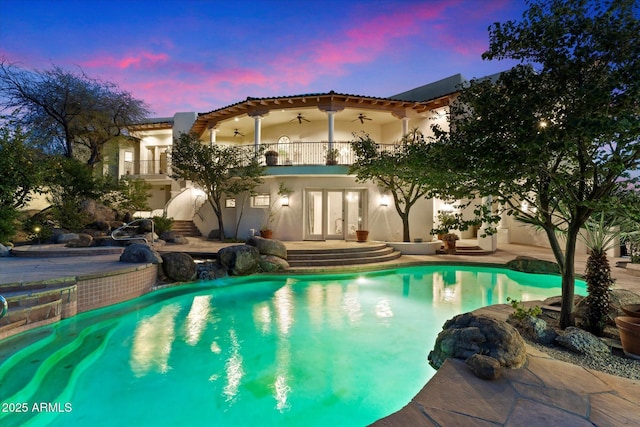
left=429, top=313, right=527, bottom=369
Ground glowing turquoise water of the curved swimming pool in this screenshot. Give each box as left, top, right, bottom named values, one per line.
left=0, top=266, right=585, bottom=427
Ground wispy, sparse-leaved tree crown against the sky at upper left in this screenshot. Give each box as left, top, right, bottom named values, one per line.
left=0, top=60, right=148, bottom=166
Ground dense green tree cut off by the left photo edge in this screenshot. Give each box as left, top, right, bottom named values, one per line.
left=0, top=123, right=46, bottom=242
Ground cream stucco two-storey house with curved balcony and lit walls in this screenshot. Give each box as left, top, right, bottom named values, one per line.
left=111, top=74, right=608, bottom=254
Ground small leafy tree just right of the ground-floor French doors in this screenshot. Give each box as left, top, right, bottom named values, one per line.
left=349, top=129, right=431, bottom=242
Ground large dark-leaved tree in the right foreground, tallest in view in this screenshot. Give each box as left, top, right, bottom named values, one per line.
left=429, top=0, right=640, bottom=328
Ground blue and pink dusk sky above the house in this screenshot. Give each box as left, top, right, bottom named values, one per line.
left=0, top=0, right=526, bottom=116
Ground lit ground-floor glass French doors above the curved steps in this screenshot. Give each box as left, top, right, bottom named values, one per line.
left=305, top=189, right=366, bottom=240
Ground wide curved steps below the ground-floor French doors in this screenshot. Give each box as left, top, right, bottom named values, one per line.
left=287, top=243, right=402, bottom=268
